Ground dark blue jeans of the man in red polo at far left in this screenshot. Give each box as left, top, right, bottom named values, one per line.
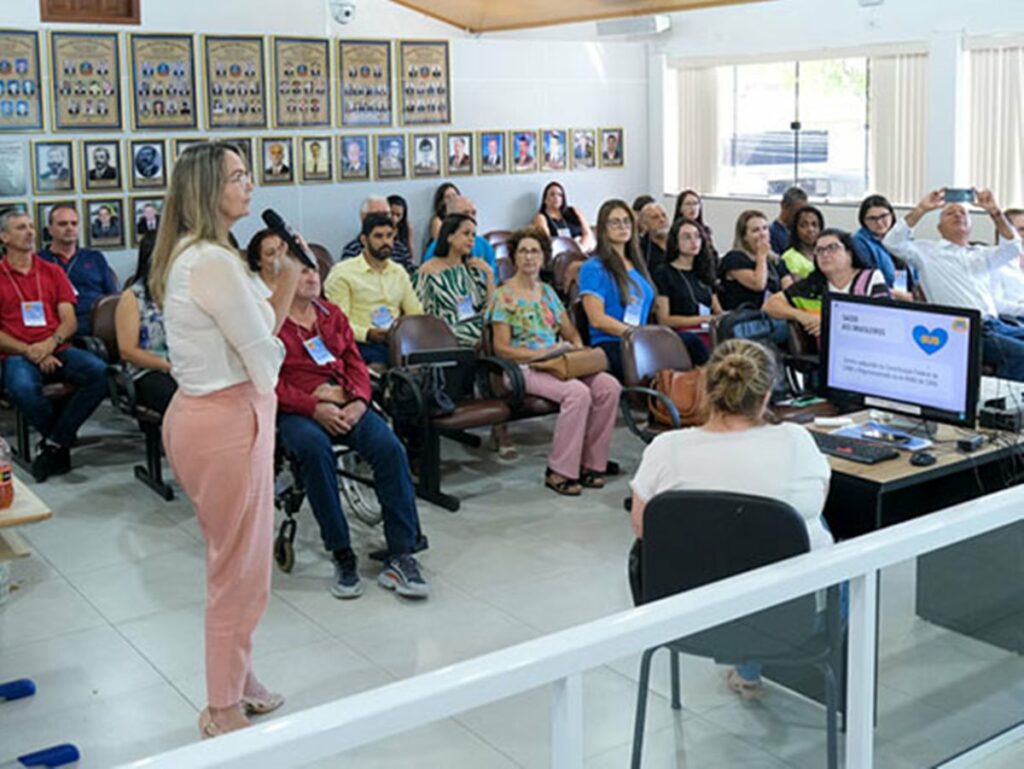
left=3, top=347, right=106, bottom=448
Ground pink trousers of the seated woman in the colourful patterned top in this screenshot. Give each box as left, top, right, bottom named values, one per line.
left=522, top=367, right=623, bottom=478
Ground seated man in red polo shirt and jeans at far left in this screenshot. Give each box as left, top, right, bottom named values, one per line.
left=0, top=211, right=106, bottom=481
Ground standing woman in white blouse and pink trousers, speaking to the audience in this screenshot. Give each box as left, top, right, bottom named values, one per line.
left=150, top=141, right=300, bottom=737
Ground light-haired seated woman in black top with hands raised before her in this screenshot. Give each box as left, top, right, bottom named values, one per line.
left=719, top=211, right=793, bottom=310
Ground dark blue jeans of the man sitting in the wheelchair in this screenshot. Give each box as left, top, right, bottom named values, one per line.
left=278, top=409, right=420, bottom=555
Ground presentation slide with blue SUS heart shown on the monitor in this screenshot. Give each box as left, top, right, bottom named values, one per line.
left=828, top=302, right=971, bottom=414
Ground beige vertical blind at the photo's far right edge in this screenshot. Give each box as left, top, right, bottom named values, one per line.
left=969, top=48, right=1024, bottom=208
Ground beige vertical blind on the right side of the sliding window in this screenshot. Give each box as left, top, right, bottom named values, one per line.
left=868, top=53, right=928, bottom=205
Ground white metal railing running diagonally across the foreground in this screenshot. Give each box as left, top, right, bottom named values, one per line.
left=119, top=486, right=1024, bottom=769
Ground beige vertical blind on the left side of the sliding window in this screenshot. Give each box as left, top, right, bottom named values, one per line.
left=679, top=67, right=721, bottom=194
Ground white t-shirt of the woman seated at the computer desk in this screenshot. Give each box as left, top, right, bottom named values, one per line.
left=631, top=423, right=833, bottom=550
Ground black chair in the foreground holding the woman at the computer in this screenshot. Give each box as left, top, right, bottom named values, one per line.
left=632, top=492, right=843, bottom=769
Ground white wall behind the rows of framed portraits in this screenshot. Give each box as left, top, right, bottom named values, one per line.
left=3, top=0, right=648, bottom=276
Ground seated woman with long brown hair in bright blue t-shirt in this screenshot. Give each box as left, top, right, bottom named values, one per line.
left=580, top=200, right=654, bottom=382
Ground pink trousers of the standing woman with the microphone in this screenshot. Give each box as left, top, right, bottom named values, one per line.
left=164, top=383, right=278, bottom=708
